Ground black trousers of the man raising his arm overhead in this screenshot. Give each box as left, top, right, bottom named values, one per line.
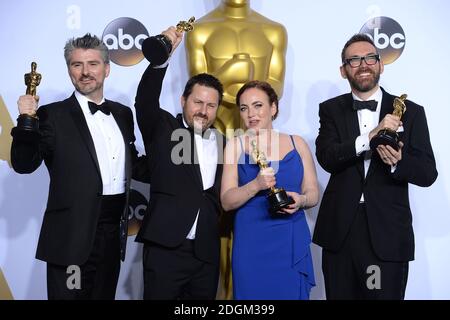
left=142, top=239, right=219, bottom=300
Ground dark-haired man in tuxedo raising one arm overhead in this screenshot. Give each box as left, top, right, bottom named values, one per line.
left=135, top=27, right=224, bottom=299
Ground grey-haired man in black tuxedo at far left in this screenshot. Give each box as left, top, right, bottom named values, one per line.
left=11, top=34, right=147, bottom=300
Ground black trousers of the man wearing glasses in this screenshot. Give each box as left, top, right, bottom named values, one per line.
left=322, top=204, right=408, bottom=300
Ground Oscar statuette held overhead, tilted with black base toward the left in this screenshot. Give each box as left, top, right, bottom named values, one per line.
left=142, top=17, right=195, bottom=66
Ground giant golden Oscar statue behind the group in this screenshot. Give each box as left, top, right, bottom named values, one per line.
left=186, top=0, right=287, bottom=299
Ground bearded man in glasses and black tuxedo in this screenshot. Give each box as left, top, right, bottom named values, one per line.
left=313, top=34, right=437, bottom=299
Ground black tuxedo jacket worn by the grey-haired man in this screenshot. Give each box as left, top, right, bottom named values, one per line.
left=11, top=94, right=147, bottom=266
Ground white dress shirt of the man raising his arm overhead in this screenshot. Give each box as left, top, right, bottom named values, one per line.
left=183, top=119, right=218, bottom=240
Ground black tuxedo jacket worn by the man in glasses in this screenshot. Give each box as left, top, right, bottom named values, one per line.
left=313, top=89, right=438, bottom=262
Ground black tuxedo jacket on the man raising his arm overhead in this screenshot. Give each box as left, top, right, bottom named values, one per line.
left=135, top=66, right=224, bottom=263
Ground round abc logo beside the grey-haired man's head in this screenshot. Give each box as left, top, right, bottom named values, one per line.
left=102, top=18, right=148, bottom=66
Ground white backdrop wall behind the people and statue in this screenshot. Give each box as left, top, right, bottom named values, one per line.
left=0, top=0, right=450, bottom=299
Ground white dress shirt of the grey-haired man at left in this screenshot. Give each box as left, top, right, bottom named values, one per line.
left=75, top=91, right=125, bottom=195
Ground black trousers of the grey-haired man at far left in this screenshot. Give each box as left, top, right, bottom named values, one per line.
left=47, top=194, right=125, bottom=300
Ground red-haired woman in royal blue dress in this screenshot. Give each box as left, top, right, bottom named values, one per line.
left=221, top=81, right=319, bottom=300
